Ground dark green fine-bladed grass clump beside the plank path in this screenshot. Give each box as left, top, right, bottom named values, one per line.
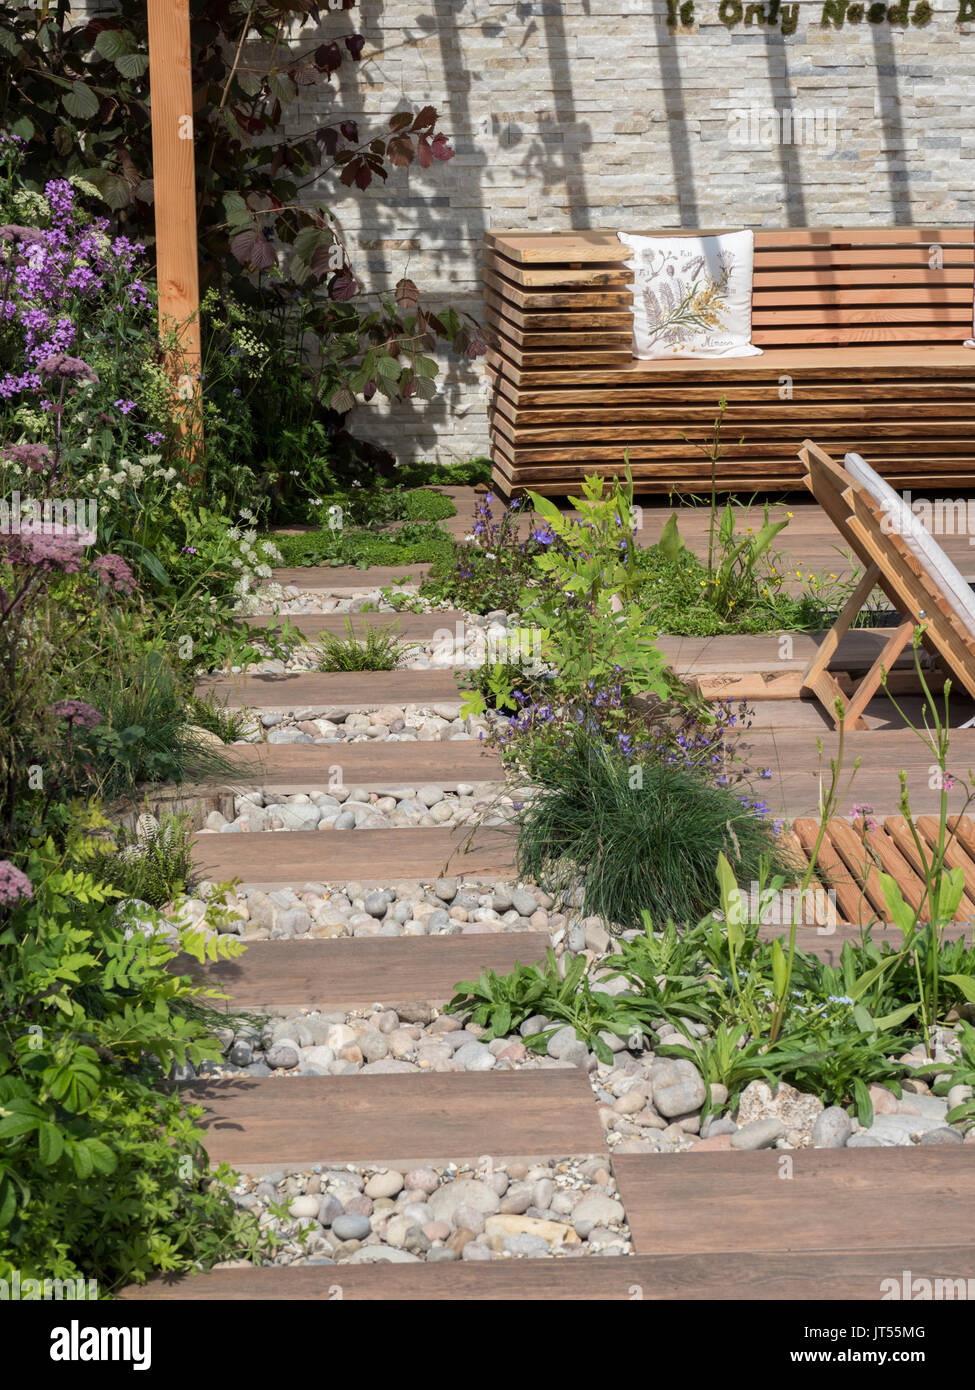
left=517, top=731, right=789, bottom=930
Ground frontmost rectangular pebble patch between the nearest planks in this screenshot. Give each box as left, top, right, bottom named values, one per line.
left=222, top=1156, right=633, bottom=1265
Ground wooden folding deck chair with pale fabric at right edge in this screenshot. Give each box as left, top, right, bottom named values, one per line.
left=798, top=439, right=975, bottom=728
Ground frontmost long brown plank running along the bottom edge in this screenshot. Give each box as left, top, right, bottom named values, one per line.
left=123, top=1245, right=975, bottom=1302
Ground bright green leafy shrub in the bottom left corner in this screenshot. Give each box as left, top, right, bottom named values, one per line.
left=0, top=827, right=260, bottom=1293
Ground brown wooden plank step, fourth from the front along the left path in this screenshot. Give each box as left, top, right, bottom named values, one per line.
left=186, top=827, right=515, bottom=890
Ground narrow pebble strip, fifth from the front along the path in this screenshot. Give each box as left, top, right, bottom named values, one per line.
left=228, top=706, right=505, bottom=744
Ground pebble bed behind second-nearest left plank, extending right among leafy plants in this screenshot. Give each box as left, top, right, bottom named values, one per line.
left=187, top=981, right=975, bottom=1154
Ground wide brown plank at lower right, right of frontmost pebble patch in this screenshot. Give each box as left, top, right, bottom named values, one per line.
left=613, top=1144, right=975, bottom=1276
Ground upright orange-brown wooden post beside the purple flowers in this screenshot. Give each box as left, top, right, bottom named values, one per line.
left=147, top=0, right=202, bottom=453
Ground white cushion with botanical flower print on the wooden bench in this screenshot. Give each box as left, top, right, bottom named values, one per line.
left=619, top=232, right=762, bottom=357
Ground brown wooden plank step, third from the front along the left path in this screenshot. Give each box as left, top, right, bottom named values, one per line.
left=172, top=931, right=548, bottom=1015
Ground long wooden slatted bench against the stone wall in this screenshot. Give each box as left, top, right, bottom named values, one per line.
left=484, top=227, right=975, bottom=495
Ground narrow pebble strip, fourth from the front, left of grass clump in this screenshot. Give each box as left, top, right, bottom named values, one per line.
left=199, top=783, right=520, bottom=835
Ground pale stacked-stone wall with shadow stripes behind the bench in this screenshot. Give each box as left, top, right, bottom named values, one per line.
left=296, top=0, right=975, bottom=460
